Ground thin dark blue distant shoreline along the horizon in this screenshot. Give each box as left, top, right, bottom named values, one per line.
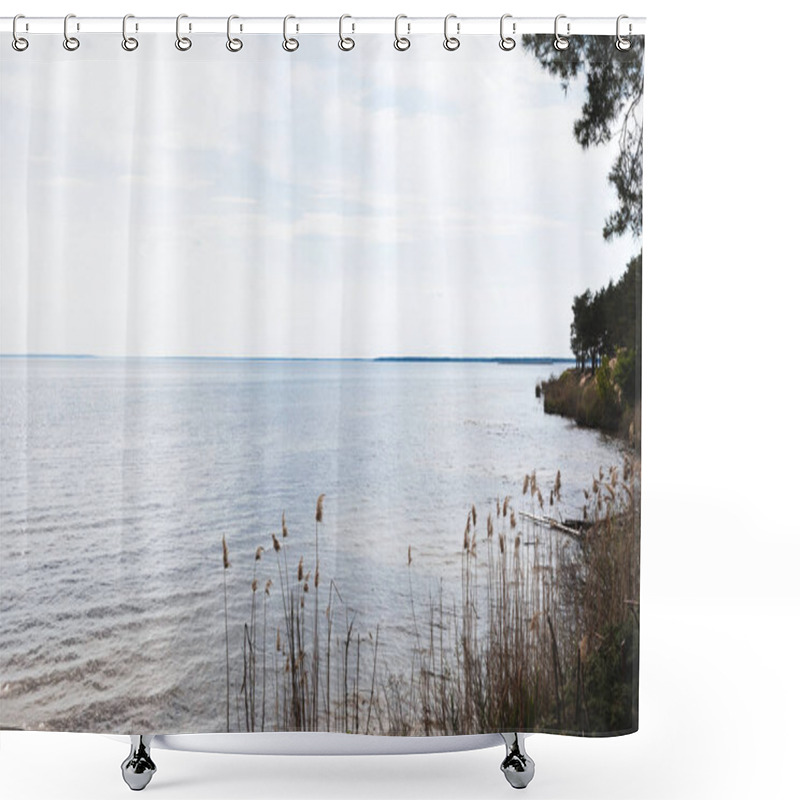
left=0, top=353, right=574, bottom=365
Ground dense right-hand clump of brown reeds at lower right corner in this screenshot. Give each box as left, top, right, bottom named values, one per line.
left=406, top=465, right=639, bottom=734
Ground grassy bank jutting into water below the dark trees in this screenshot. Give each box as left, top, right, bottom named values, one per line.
left=536, top=354, right=641, bottom=451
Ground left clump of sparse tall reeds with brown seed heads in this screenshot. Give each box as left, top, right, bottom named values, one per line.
left=223, top=495, right=379, bottom=732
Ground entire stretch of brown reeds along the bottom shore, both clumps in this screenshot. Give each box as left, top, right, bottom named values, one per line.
left=220, top=457, right=639, bottom=736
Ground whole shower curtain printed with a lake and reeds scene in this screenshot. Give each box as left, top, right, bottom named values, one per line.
left=0, top=20, right=644, bottom=735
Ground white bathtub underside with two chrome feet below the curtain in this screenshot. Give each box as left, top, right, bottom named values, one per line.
left=112, top=732, right=534, bottom=791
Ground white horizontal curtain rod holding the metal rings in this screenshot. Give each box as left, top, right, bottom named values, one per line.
left=0, top=15, right=645, bottom=36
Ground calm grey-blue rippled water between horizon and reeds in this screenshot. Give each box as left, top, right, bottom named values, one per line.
left=0, top=359, right=622, bottom=732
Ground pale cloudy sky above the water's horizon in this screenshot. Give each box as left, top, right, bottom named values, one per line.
left=0, top=34, right=639, bottom=358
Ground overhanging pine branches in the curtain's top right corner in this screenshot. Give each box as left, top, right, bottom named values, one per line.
left=522, top=34, right=644, bottom=239
